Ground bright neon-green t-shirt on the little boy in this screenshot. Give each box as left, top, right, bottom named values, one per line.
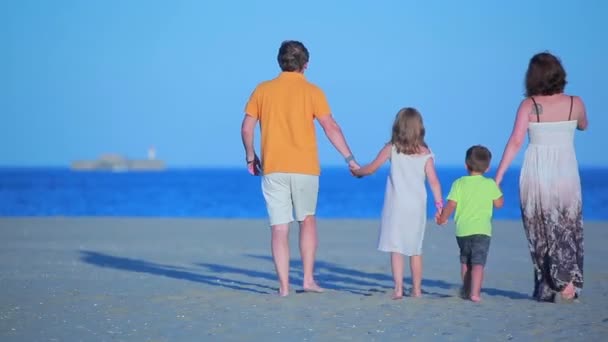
left=448, top=175, right=502, bottom=236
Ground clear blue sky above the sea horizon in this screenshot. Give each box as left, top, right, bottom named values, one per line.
left=0, top=0, right=608, bottom=167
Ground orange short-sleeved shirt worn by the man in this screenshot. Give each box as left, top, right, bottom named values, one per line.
left=245, top=72, right=331, bottom=175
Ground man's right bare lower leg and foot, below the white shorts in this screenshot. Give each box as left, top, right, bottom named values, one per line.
left=300, top=215, right=323, bottom=292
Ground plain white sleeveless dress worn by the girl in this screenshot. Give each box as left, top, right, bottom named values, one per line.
left=378, top=146, right=433, bottom=256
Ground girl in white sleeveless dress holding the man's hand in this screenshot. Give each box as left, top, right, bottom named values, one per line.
left=351, top=108, right=443, bottom=299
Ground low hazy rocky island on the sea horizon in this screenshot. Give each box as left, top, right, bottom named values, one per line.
left=71, top=154, right=166, bottom=172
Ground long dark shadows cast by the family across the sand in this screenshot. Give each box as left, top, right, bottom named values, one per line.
left=80, top=251, right=530, bottom=299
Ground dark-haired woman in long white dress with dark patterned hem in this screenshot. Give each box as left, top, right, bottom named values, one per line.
left=496, top=52, right=588, bottom=302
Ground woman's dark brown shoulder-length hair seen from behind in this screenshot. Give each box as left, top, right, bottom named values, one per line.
left=526, top=52, right=567, bottom=96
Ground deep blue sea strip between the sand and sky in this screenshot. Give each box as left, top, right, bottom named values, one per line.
left=0, top=168, right=608, bottom=220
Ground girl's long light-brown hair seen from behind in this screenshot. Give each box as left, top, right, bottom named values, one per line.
left=391, top=107, right=427, bottom=154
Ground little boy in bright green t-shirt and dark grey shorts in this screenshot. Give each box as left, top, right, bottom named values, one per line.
left=436, top=145, right=504, bottom=302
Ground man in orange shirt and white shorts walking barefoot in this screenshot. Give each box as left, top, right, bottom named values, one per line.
left=241, top=41, right=359, bottom=296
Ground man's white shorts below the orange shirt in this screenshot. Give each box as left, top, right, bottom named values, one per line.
left=262, top=172, right=319, bottom=226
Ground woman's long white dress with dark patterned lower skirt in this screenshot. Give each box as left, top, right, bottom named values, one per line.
left=519, top=120, right=583, bottom=301
